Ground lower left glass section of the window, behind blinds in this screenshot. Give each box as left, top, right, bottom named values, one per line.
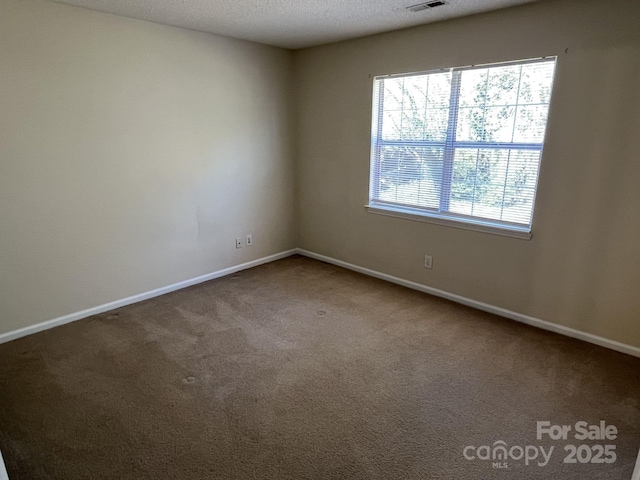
left=377, top=145, right=444, bottom=208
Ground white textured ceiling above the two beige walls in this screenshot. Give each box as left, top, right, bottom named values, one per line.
left=54, top=0, right=537, bottom=49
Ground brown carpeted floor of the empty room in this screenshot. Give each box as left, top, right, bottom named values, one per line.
left=0, top=256, right=640, bottom=480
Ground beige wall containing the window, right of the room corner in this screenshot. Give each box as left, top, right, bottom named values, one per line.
left=295, top=0, right=640, bottom=346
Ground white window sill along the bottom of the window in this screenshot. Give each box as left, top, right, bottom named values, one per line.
left=364, top=205, right=532, bottom=240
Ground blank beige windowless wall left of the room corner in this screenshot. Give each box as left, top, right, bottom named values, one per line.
left=0, top=0, right=296, bottom=333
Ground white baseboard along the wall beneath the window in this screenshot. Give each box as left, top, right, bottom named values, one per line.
left=296, top=248, right=640, bottom=358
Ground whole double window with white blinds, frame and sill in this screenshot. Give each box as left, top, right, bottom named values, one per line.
left=367, top=57, right=556, bottom=238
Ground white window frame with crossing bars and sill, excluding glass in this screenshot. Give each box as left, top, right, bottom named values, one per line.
left=365, top=56, right=557, bottom=240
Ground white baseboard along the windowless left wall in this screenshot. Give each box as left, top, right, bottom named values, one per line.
left=0, top=248, right=297, bottom=346
